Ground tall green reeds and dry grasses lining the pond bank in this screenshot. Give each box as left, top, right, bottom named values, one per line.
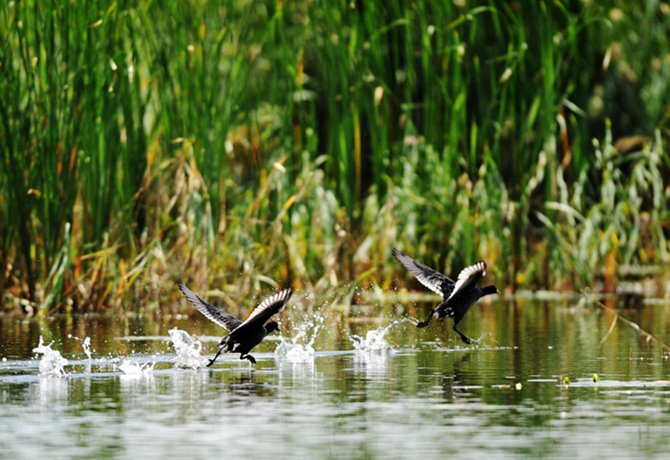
left=0, top=0, right=670, bottom=313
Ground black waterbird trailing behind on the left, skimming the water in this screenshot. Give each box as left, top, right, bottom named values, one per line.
left=177, top=280, right=293, bottom=367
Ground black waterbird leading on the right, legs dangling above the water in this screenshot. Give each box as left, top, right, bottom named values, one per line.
left=392, top=248, right=500, bottom=344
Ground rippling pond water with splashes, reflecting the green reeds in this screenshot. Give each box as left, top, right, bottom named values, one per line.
left=0, top=299, right=670, bottom=459
